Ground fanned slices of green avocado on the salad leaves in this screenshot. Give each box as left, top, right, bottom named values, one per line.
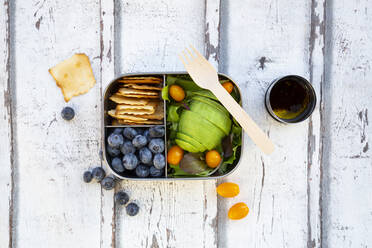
left=175, top=95, right=231, bottom=152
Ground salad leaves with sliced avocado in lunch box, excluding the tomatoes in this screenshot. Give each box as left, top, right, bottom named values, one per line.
left=162, top=75, right=242, bottom=177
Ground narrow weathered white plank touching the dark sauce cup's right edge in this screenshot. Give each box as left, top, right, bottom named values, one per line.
left=307, top=0, right=326, bottom=248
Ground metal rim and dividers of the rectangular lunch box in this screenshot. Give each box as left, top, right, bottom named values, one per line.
left=101, top=72, right=244, bottom=181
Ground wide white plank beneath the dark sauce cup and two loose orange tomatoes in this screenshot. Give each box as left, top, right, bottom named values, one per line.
left=218, top=0, right=313, bottom=247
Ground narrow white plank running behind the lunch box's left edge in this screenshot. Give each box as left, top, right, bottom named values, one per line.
left=100, top=0, right=116, bottom=247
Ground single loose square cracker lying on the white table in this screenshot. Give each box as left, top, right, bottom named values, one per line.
left=49, top=53, right=96, bottom=102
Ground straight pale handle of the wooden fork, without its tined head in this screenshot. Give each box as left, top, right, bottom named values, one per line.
left=210, top=83, right=274, bottom=154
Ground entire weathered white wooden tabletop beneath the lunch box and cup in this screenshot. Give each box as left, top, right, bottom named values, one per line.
left=0, top=0, right=372, bottom=248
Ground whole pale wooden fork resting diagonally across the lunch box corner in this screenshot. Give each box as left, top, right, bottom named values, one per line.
left=180, top=45, right=274, bottom=154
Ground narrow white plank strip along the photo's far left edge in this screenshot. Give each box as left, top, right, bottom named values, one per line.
left=0, top=1, right=14, bottom=247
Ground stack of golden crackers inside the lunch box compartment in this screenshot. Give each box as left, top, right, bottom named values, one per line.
left=108, top=77, right=164, bottom=125
